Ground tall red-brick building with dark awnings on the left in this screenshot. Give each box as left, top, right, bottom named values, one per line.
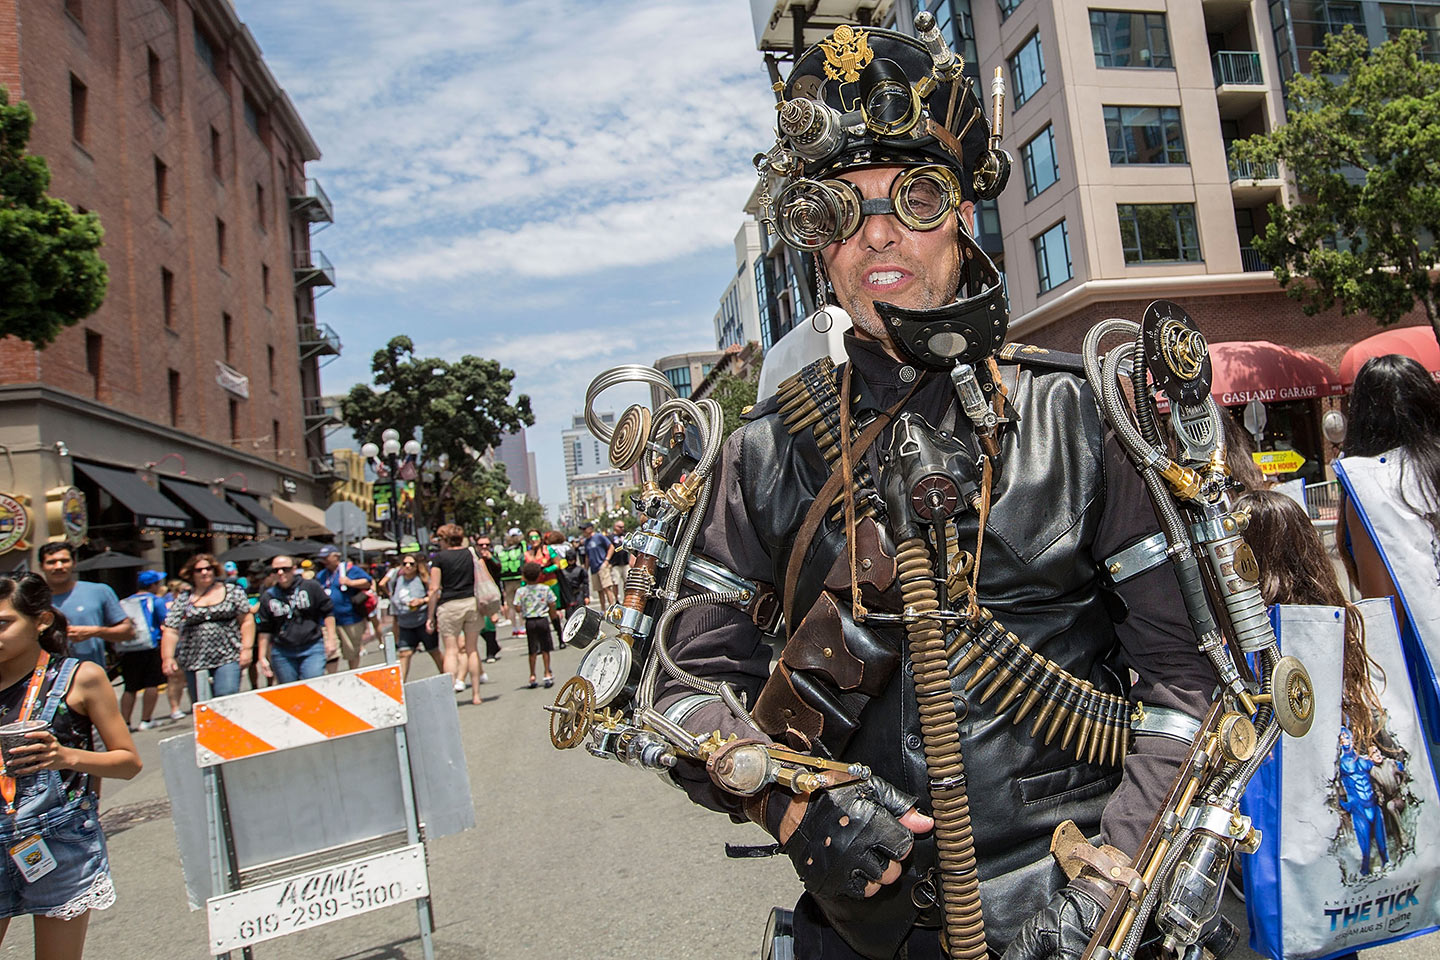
left=0, top=0, right=340, bottom=569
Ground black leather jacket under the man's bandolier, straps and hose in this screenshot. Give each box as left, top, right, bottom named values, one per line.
left=672, top=341, right=1214, bottom=957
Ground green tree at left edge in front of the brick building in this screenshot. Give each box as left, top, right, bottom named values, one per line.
left=0, top=86, right=109, bottom=348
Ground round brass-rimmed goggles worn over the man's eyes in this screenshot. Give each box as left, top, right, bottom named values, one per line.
left=775, top=164, right=962, bottom=250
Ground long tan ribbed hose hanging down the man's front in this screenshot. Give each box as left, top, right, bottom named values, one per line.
left=896, top=537, right=986, bottom=960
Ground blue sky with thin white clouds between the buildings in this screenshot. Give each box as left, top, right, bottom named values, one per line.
left=246, top=0, right=775, bottom=517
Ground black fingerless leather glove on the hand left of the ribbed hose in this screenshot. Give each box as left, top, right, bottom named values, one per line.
left=780, top=777, right=916, bottom=900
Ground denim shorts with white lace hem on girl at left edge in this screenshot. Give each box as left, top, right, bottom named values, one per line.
left=0, top=793, right=115, bottom=920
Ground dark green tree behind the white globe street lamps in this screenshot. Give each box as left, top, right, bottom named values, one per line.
left=340, top=337, right=536, bottom=530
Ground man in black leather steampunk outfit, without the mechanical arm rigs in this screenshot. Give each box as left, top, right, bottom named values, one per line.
left=660, top=20, right=1215, bottom=960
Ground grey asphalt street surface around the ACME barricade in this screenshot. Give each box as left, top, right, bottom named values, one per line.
left=0, top=628, right=1440, bottom=960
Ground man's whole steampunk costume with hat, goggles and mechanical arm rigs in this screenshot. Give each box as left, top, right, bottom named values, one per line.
left=549, top=16, right=1310, bottom=960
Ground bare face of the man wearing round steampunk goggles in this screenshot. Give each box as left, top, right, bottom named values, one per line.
left=821, top=167, right=973, bottom=344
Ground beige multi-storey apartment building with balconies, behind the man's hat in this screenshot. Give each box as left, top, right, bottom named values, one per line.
left=971, top=0, right=1436, bottom=364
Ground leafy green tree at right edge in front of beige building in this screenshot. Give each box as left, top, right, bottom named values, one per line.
left=1233, top=26, right=1440, bottom=346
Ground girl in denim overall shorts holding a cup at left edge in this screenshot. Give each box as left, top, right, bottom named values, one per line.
left=0, top=573, right=140, bottom=960
